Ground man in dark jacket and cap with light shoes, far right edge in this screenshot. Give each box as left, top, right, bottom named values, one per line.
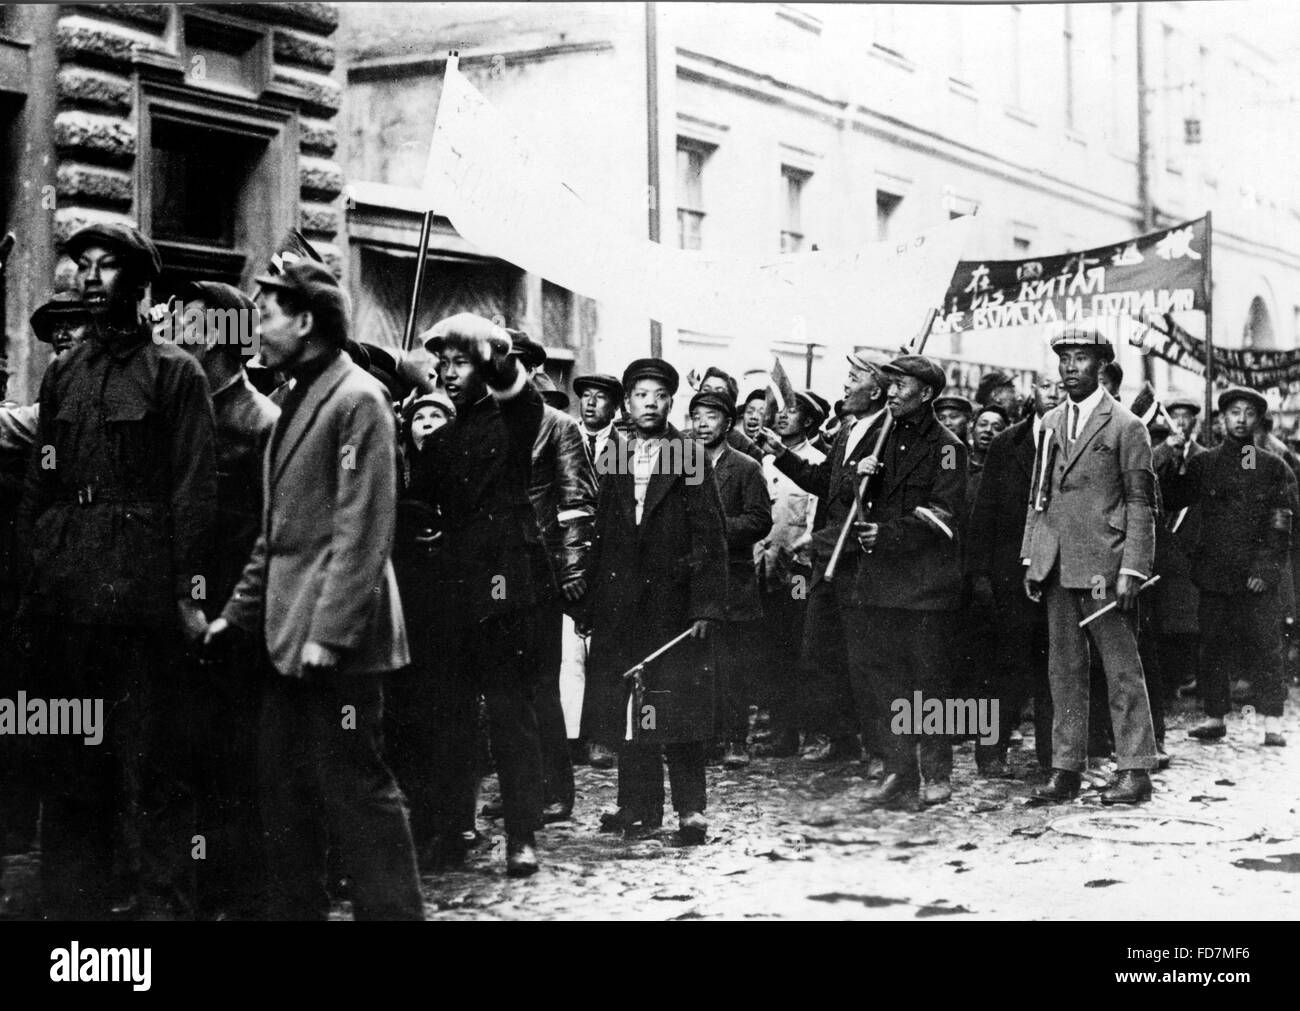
left=1161, top=387, right=1294, bottom=745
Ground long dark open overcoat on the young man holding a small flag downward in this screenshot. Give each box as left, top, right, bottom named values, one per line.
left=582, top=425, right=727, bottom=746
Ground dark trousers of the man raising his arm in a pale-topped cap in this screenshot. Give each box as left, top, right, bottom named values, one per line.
left=430, top=609, right=543, bottom=836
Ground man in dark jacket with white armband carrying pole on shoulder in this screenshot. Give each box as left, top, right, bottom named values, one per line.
left=854, top=355, right=967, bottom=807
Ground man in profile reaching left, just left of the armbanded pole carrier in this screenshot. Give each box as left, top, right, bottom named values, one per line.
left=761, top=351, right=889, bottom=761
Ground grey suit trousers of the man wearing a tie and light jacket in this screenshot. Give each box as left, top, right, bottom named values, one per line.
left=1044, top=573, right=1156, bottom=772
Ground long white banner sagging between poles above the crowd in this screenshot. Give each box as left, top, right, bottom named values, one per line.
left=424, top=61, right=970, bottom=347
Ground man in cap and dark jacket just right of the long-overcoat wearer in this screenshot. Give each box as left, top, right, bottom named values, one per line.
left=690, top=391, right=772, bottom=768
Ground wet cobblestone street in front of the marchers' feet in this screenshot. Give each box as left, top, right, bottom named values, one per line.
left=424, top=689, right=1300, bottom=914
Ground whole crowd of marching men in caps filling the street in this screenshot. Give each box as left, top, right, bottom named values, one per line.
left=0, top=225, right=1300, bottom=919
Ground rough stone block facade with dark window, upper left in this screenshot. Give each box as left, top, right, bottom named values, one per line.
left=0, top=3, right=343, bottom=402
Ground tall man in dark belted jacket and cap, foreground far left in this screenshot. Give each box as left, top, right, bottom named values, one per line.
left=20, top=225, right=216, bottom=919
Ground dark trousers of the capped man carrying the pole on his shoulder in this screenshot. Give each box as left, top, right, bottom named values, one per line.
left=850, top=607, right=956, bottom=784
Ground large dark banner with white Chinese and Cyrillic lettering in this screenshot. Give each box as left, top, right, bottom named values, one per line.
left=933, top=218, right=1209, bottom=334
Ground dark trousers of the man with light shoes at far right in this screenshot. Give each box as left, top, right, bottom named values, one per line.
left=1200, top=590, right=1287, bottom=719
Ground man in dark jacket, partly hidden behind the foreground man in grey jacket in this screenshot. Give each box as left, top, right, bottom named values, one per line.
left=178, top=281, right=280, bottom=919
